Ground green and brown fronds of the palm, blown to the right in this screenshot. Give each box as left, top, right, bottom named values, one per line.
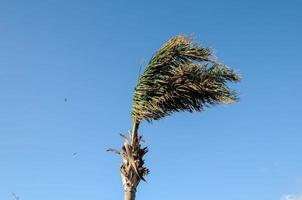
left=132, top=36, right=240, bottom=123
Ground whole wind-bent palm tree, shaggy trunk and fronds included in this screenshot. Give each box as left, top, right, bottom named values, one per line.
left=108, top=36, right=240, bottom=200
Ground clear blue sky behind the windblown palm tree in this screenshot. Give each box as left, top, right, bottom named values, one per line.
left=0, top=0, right=302, bottom=200
